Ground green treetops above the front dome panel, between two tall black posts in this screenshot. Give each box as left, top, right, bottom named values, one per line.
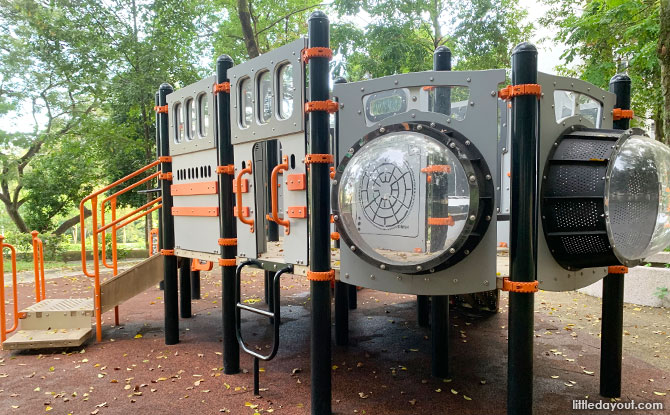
left=332, top=0, right=532, bottom=80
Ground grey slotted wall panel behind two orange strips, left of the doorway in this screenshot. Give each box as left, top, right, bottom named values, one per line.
left=172, top=148, right=220, bottom=254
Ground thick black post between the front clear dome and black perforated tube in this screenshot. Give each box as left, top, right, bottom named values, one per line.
left=507, top=42, right=539, bottom=415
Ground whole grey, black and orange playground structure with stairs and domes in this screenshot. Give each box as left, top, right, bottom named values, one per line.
left=0, top=12, right=670, bottom=414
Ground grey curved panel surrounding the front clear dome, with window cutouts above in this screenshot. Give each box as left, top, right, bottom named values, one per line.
left=333, top=70, right=505, bottom=295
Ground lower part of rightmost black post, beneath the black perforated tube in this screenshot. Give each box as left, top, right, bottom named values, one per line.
left=600, top=274, right=624, bottom=398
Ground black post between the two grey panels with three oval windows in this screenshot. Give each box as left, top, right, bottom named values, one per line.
left=216, top=55, right=240, bottom=375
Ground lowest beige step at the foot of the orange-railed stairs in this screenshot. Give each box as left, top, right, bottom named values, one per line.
left=2, top=328, right=93, bottom=350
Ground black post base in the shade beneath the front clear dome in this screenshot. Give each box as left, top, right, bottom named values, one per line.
left=430, top=295, right=449, bottom=378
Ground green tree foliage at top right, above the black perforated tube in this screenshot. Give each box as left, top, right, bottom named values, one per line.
left=541, top=0, right=670, bottom=142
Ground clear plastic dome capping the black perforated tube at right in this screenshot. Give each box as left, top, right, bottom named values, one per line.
left=605, top=135, right=670, bottom=262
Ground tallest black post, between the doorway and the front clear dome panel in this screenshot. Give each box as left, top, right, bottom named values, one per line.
left=307, top=11, right=332, bottom=415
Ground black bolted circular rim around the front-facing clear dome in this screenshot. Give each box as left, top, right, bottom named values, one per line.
left=331, top=121, right=494, bottom=274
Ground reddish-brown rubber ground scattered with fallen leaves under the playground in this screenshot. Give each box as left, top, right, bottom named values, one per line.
left=0, top=273, right=670, bottom=415
